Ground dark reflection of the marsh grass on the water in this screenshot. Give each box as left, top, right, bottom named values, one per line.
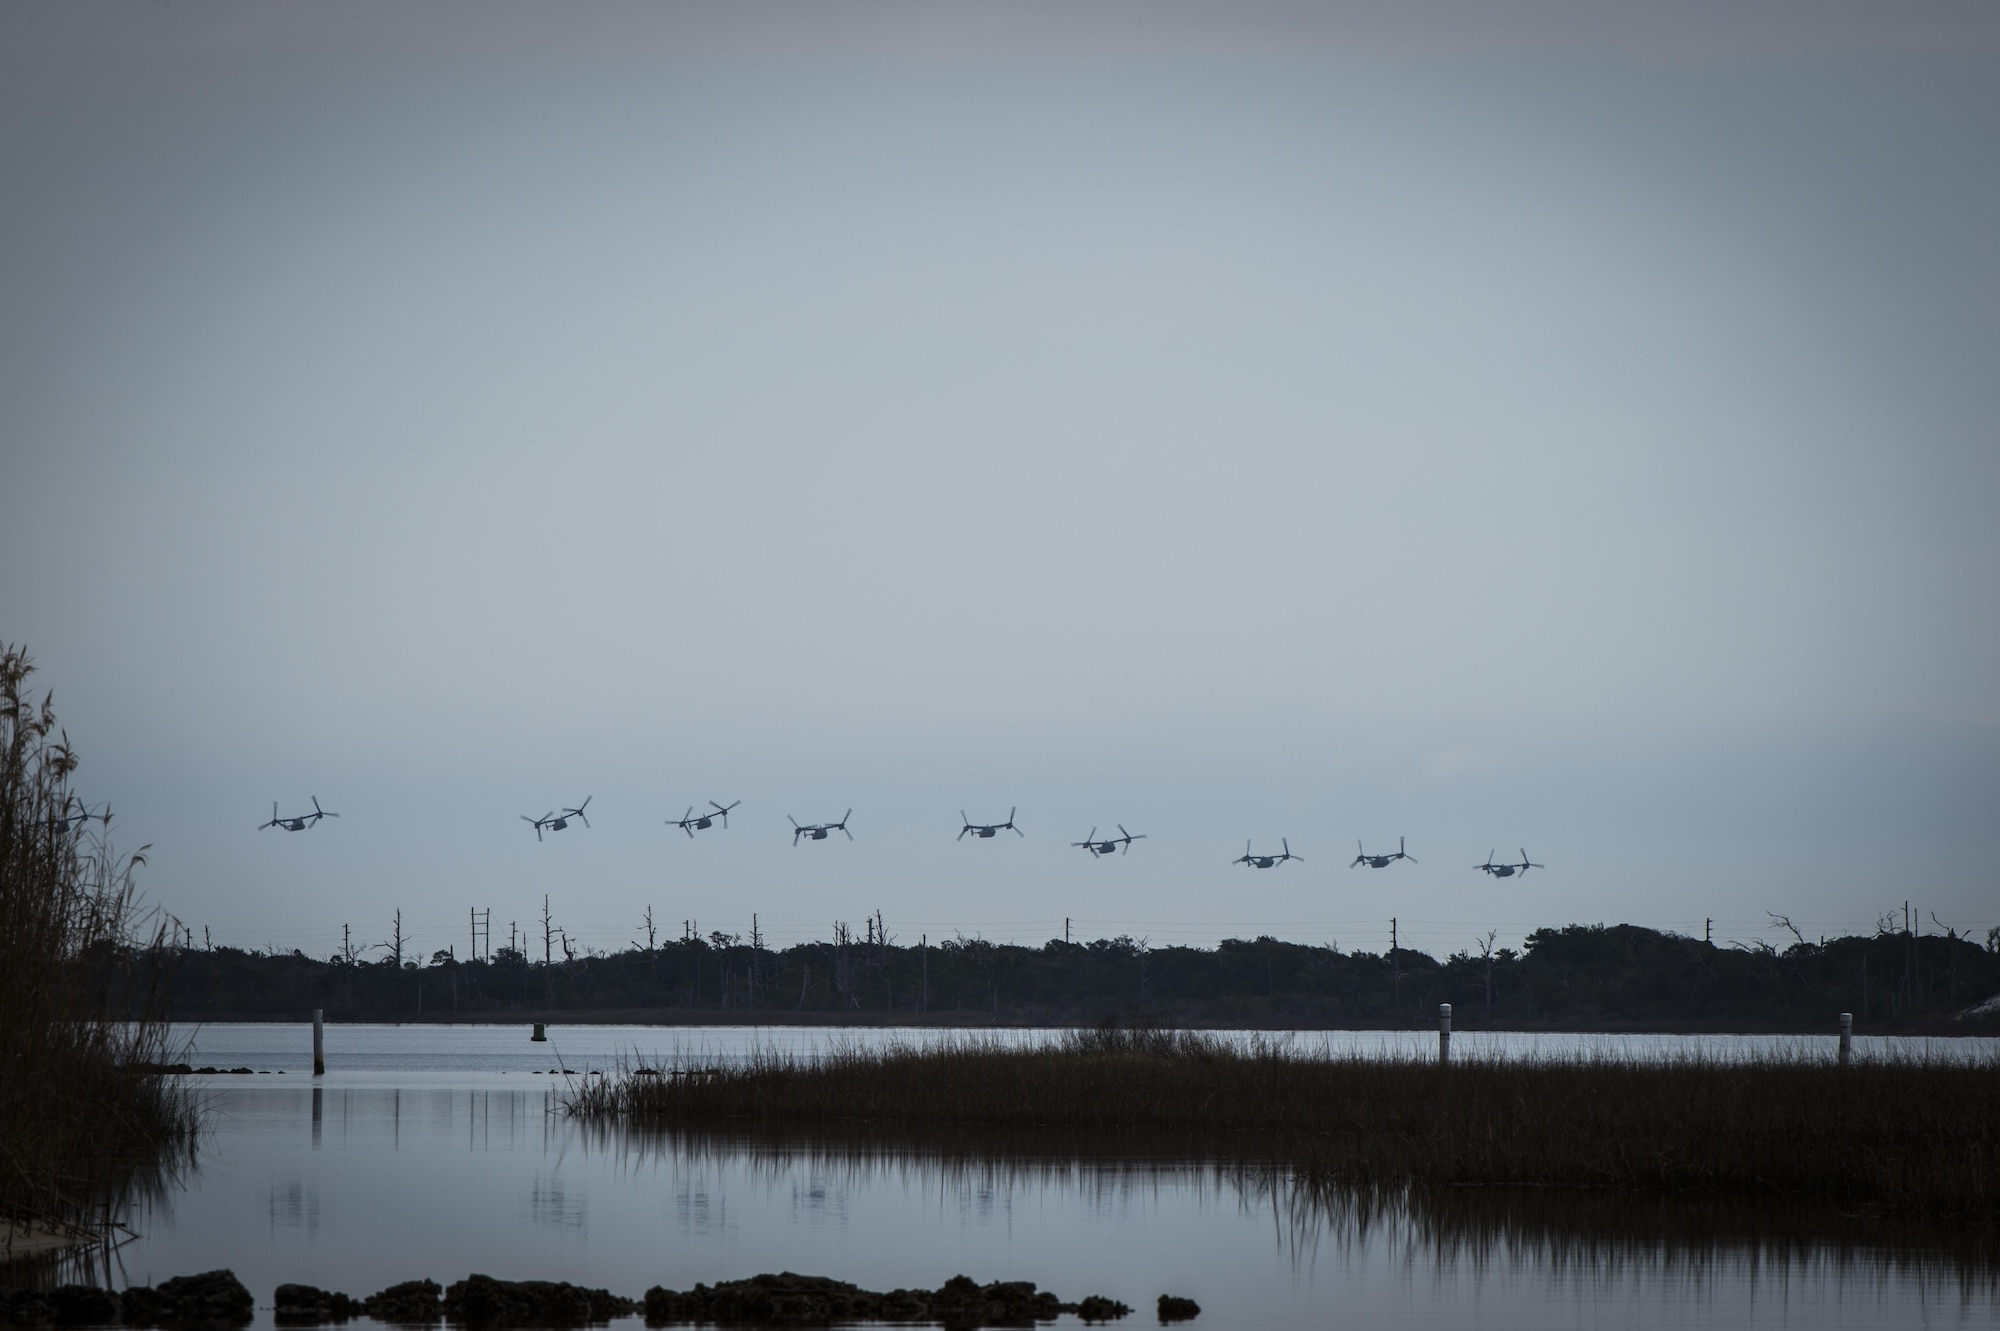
left=582, top=1127, right=2000, bottom=1303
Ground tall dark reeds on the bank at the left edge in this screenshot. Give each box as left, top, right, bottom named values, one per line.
left=0, top=646, right=196, bottom=1261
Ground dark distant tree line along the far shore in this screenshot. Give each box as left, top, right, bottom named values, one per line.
left=148, top=911, right=2000, bottom=1035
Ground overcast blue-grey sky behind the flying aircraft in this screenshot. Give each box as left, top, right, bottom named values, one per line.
left=0, top=2, right=2000, bottom=953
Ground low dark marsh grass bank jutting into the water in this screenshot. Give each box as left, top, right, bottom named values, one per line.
left=570, top=1029, right=2000, bottom=1225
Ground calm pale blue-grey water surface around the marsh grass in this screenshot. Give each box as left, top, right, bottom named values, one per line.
left=97, top=1025, right=2000, bottom=1329
